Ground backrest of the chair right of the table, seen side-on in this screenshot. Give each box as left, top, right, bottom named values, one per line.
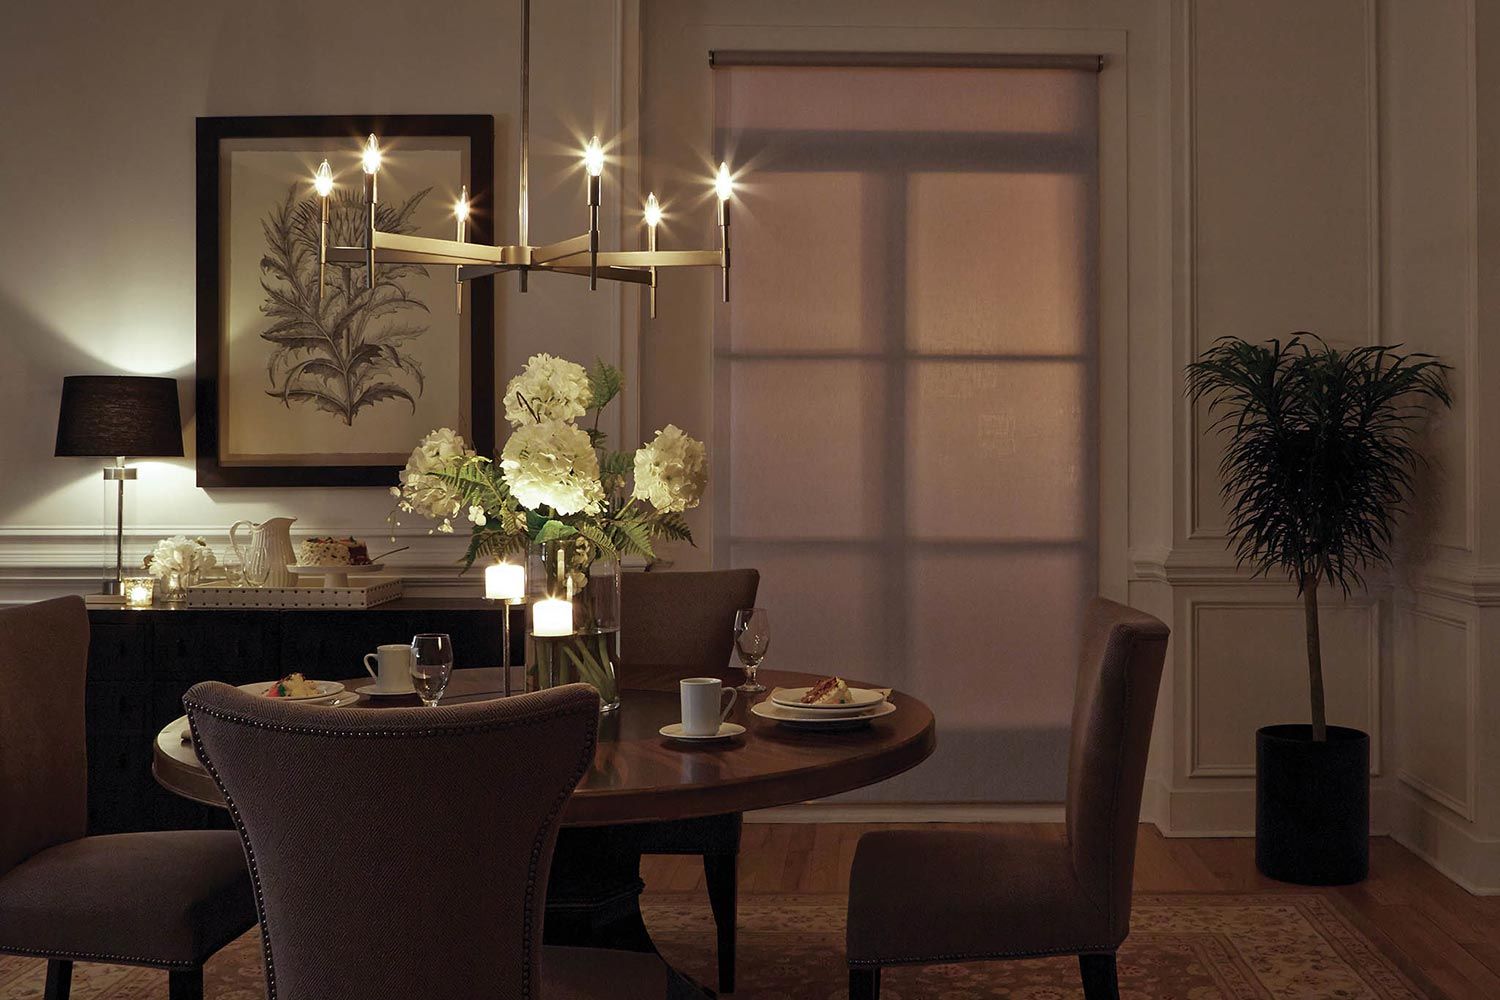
left=1067, top=598, right=1169, bottom=937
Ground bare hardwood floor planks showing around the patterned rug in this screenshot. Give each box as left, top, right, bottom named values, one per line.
left=641, top=823, right=1500, bottom=1000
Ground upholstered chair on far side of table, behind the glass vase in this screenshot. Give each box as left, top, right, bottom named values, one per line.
left=620, top=570, right=761, bottom=993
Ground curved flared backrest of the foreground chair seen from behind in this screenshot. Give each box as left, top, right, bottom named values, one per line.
left=183, top=682, right=599, bottom=1000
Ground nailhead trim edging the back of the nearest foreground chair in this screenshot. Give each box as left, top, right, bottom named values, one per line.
left=183, top=699, right=599, bottom=1000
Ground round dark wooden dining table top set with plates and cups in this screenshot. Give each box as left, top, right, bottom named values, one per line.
left=161, top=669, right=938, bottom=826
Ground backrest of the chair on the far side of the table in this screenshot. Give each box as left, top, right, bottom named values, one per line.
left=620, top=570, right=761, bottom=687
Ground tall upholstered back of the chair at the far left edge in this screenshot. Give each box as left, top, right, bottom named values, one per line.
left=0, top=597, right=89, bottom=876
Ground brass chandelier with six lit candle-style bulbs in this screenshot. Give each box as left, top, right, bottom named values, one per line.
left=312, top=0, right=734, bottom=318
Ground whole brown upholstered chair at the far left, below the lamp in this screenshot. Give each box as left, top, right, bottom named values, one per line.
left=0, top=597, right=255, bottom=1000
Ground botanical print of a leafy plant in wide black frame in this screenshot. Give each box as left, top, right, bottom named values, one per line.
left=198, top=115, right=495, bottom=487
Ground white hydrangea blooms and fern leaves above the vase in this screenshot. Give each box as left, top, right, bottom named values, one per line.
left=392, top=354, right=708, bottom=568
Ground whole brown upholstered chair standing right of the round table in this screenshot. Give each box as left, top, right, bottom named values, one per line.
left=848, top=600, right=1167, bottom=1000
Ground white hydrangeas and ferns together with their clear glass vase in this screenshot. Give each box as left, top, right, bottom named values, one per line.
left=392, top=354, right=708, bottom=712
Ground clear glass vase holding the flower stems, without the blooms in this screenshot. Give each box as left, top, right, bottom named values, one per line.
left=527, top=535, right=620, bottom=712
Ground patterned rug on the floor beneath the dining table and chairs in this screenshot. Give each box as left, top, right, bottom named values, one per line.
left=0, top=892, right=1442, bottom=1000
